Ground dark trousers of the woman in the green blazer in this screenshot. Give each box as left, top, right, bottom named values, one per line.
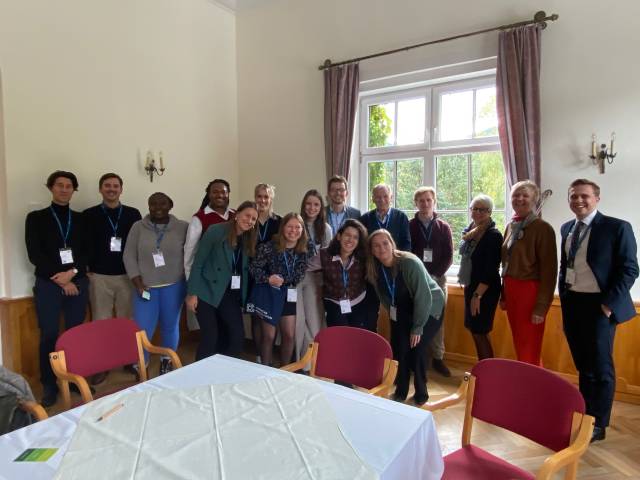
left=196, top=289, right=244, bottom=361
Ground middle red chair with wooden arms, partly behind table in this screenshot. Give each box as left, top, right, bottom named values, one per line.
left=282, top=327, right=398, bottom=397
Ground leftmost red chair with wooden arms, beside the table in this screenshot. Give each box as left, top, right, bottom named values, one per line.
left=49, top=318, right=182, bottom=409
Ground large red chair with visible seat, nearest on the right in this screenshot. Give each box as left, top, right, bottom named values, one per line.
left=422, top=358, right=594, bottom=480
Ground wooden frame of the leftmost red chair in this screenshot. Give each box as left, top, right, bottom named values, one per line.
left=49, top=330, right=182, bottom=410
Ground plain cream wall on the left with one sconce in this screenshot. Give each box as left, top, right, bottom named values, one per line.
left=0, top=0, right=239, bottom=297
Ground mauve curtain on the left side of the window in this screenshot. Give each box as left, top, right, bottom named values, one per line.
left=324, top=63, right=359, bottom=180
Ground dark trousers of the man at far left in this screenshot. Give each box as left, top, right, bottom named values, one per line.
left=33, top=277, right=89, bottom=390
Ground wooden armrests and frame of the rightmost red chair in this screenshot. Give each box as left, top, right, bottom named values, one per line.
left=422, top=372, right=595, bottom=480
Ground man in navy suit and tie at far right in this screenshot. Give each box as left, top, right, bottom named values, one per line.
left=558, top=179, right=638, bottom=442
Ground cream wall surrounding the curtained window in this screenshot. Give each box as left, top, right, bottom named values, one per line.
left=237, top=0, right=640, bottom=298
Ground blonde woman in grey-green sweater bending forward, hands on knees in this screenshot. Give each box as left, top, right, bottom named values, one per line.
left=367, top=229, right=444, bottom=405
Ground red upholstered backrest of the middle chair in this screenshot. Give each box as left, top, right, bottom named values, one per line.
left=314, top=327, right=393, bottom=389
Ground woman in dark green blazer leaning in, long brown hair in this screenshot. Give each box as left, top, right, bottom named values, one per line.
left=187, top=201, right=258, bottom=360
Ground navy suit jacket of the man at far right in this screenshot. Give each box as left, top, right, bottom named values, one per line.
left=558, top=212, right=638, bottom=323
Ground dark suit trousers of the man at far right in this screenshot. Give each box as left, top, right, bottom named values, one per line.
left=560, top=291, right=617, bottom=427
